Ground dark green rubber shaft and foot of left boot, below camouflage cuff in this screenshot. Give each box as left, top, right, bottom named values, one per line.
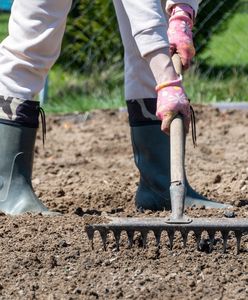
left=0, top=122, right=55, bottom=215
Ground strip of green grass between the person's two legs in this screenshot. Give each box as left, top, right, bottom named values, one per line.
left=45, top=65, right=125, bottom=113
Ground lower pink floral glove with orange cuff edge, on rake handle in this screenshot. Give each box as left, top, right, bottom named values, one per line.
left=156, top=78, right=190, bottom=134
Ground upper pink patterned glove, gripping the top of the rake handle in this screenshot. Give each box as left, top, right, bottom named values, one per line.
left=167, top=4, right=195, bottom=69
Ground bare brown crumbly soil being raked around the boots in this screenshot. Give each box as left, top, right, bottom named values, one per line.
left=0, top=106, right=248, bottom=300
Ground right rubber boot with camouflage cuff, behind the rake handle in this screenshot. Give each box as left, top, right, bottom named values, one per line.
left=127, top=99, right=231, bottom=211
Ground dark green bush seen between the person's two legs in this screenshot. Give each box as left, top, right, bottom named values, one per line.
left=61, top=0, right=123, bottom=72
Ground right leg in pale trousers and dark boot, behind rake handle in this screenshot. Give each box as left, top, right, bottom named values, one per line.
left=114, top=0, right=231, bottom=210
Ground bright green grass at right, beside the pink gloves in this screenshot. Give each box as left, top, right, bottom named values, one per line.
left=192, top=9, right=248, bottom=103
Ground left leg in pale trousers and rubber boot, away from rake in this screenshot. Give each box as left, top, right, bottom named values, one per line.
left=0, top=0, right=71, bottom=215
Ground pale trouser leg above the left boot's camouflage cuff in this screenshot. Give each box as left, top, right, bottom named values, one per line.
left=0, top=0, right=72, bottom=100
